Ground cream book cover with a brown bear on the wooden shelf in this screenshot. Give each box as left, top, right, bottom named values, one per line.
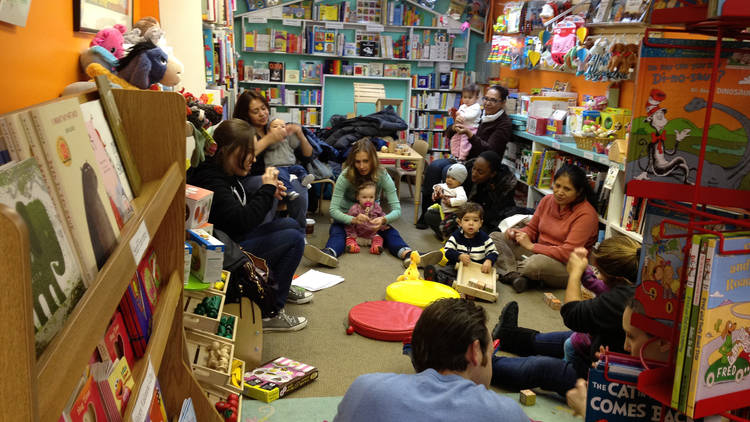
left=29, top=98, right=120, bottom=280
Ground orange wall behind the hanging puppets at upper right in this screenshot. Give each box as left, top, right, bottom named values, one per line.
left=500, top=66, right=635, bottom=108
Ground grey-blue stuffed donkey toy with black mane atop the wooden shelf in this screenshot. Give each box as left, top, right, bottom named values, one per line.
left=117, top=41, right=169, bottom=89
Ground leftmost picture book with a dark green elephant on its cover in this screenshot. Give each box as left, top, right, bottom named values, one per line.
left=0, top=158, right=86, bottom=356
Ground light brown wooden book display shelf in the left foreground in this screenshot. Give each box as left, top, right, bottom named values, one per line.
left=0, top=90, right=222, bottom=421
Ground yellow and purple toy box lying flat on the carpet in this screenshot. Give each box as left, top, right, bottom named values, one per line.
left=243, top=357, right=318, bottom=403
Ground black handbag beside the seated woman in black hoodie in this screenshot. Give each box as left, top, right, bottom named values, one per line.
left=214, top=229, right=278, bottom=317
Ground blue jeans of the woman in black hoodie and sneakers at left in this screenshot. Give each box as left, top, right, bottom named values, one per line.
left=240, top=217, right=305, bottom=310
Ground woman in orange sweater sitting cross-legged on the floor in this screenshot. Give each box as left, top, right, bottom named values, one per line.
left=490, top=164, right=599, bottom=293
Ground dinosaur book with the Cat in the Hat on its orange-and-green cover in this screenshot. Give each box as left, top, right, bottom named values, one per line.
left=626, top=39, right=750, bottom=205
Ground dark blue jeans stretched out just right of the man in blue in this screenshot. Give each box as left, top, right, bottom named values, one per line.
left=492, top=331, right=588, bottom=396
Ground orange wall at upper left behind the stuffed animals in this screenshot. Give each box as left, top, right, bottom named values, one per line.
left=0, top=0, right=159, bottom=113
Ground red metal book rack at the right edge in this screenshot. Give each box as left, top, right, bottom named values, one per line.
left=627, top=22, right=750, bottom=420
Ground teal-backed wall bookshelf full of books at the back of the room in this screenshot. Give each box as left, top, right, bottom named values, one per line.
left=235, top=0, right=480, bottom=127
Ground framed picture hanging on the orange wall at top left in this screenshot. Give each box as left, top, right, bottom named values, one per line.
left=73, top=0, right=133, bottom=33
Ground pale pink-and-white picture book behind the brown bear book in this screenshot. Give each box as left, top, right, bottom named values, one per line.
left=81, top=100, right=134, bottom=228
